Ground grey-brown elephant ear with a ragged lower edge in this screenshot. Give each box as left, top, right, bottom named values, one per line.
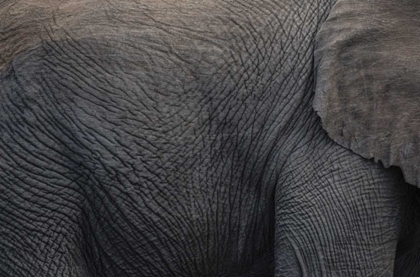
left=314, top=0, right=420, bottom=187
